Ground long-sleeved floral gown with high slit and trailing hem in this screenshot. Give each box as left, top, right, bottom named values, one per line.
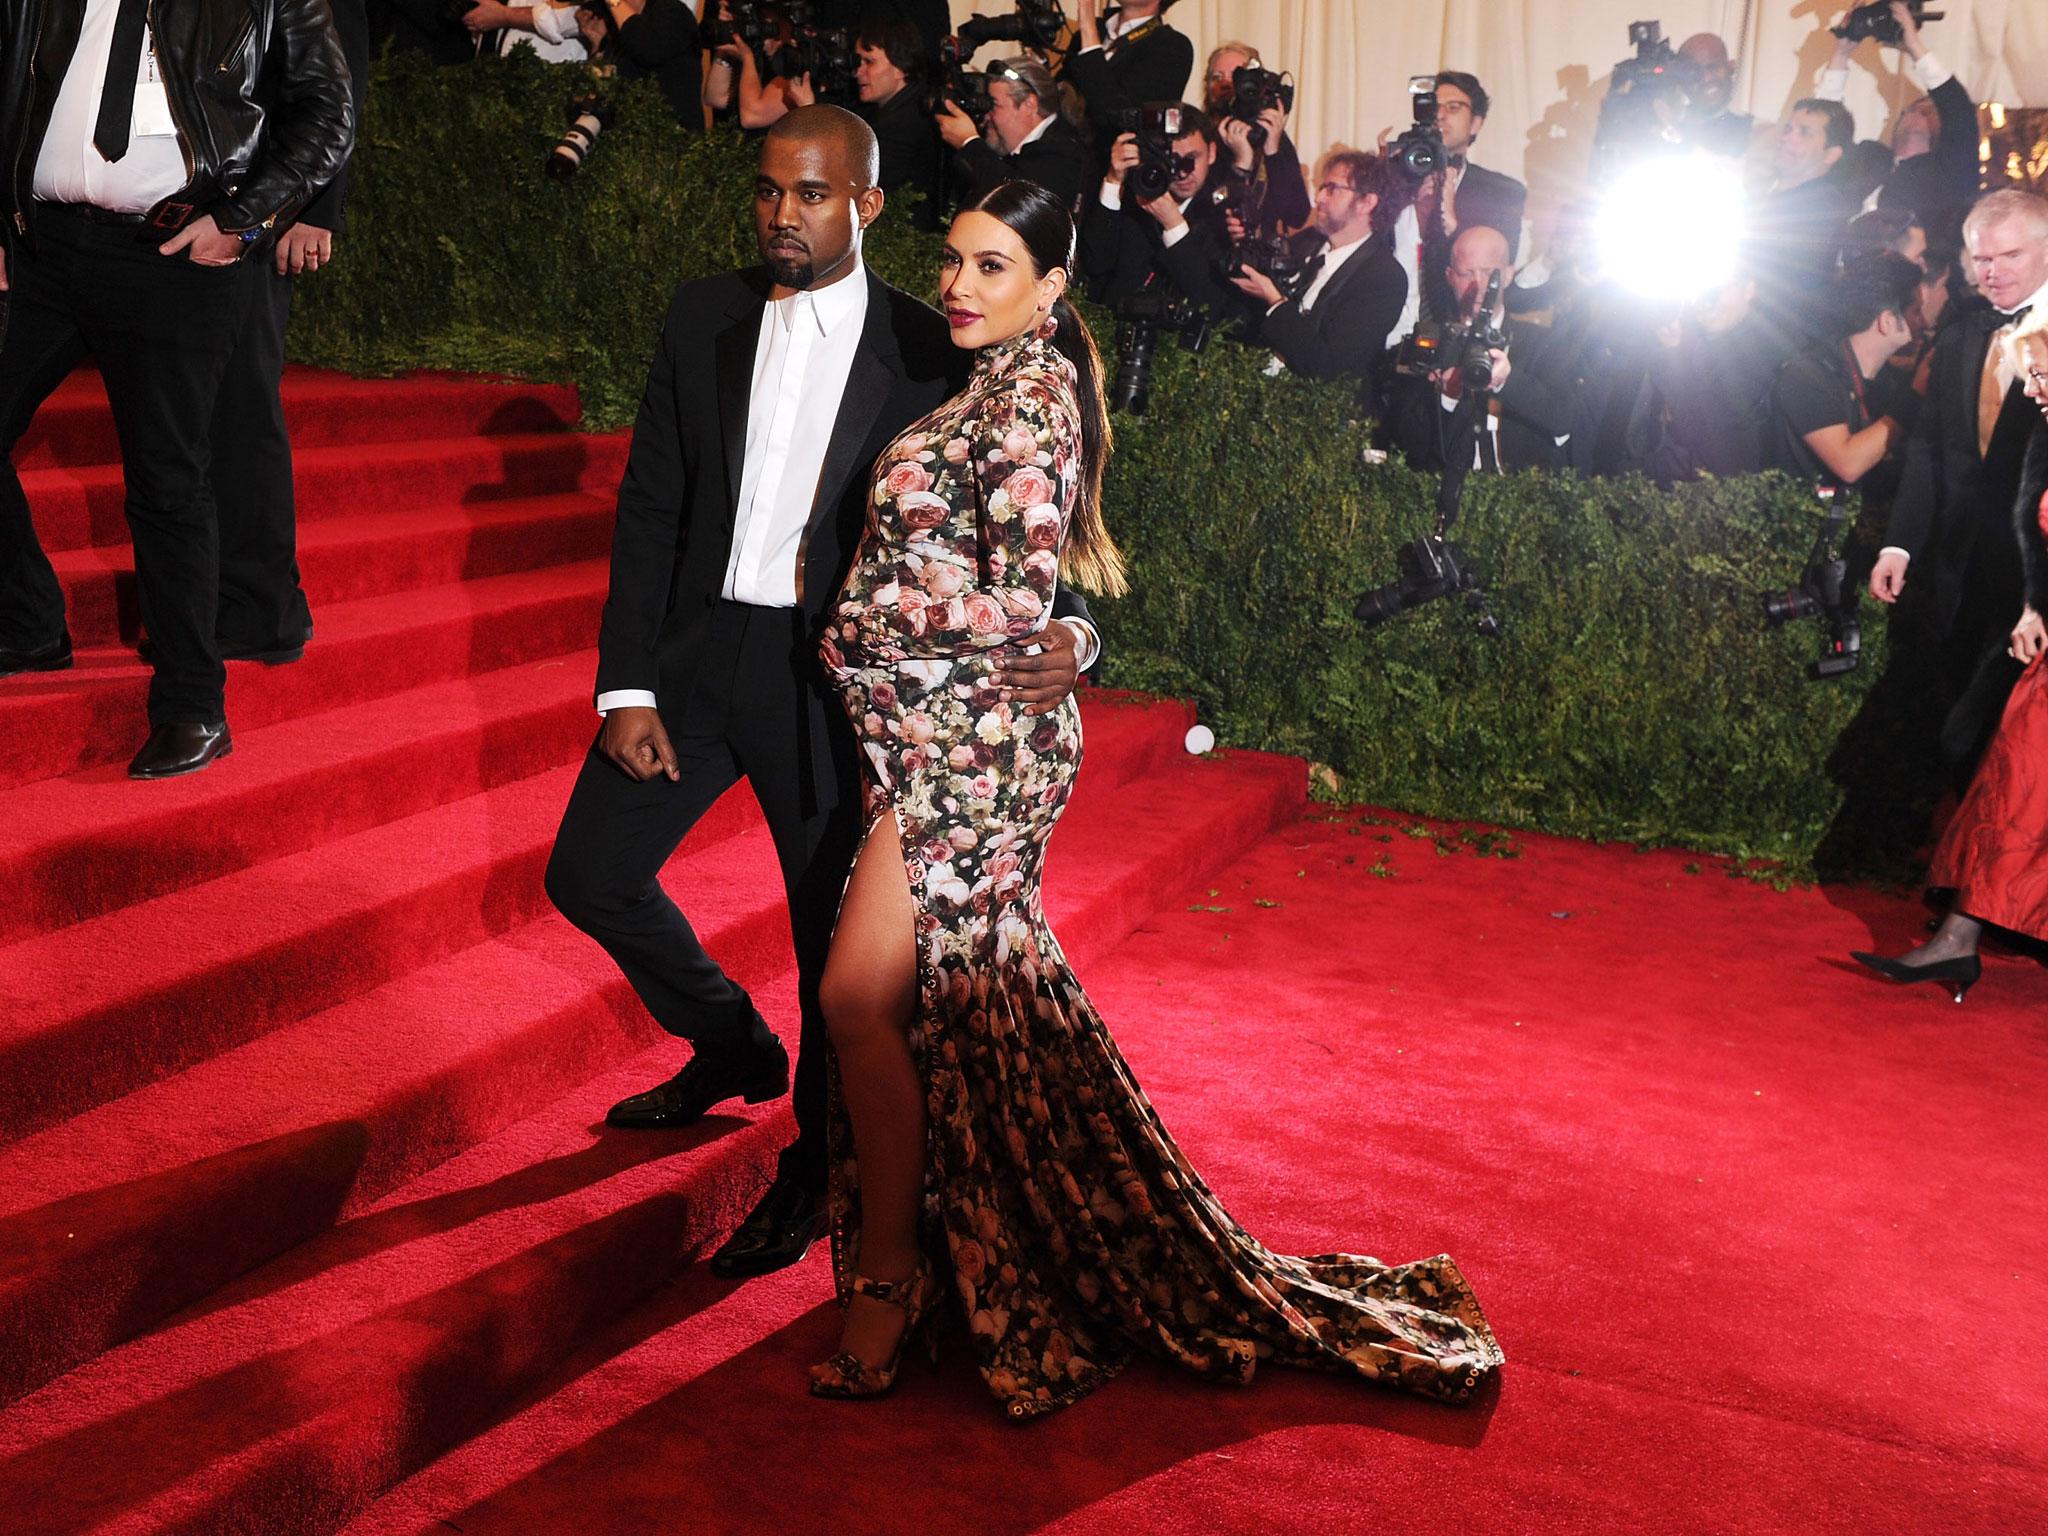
left=821, top=326, right=1501, bottom=1419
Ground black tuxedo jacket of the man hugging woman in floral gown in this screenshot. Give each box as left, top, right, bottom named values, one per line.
left=596, top=268, right=1087, bottom=805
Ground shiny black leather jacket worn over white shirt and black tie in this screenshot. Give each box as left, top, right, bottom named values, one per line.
left=0, top=0, right=356, bottom=256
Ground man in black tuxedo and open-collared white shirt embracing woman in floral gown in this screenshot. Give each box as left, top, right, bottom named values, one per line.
left=547, top=106, right=1096, bottom=1276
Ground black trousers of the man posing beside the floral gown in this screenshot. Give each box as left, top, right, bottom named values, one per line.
left=547, top=602, right=860, bottom=1192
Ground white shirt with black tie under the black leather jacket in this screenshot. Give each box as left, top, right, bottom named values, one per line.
left=31, top=0, right=190, bottom=213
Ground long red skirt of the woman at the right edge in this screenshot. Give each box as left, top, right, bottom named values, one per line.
left=1927, top=498, right=2048, bottom=938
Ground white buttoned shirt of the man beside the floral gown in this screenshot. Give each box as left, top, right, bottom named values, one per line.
left=723, top=262, right=868, bottom=608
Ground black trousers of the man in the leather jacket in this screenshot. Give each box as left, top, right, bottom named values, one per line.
left=0, top=203, right=252, bottom=725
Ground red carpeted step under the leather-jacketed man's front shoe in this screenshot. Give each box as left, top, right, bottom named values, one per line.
left=0, top=559, right=610, bottom=786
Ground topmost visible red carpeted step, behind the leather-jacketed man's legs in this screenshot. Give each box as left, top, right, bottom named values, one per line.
left=14, top=365, right=580, bottom=469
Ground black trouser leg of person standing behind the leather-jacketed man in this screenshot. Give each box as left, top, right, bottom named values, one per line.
left=213, top=258, right=313, bottom=651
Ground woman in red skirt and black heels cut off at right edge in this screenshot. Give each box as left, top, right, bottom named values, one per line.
left=1851, top=313, right=2048, bottom=1004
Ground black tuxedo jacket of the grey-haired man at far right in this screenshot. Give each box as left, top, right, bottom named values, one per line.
left=1884, top=309, right=2040, bottom=643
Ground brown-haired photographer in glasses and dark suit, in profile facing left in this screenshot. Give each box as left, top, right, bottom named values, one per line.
left=1231, top=152, right=1407, bottom=391
